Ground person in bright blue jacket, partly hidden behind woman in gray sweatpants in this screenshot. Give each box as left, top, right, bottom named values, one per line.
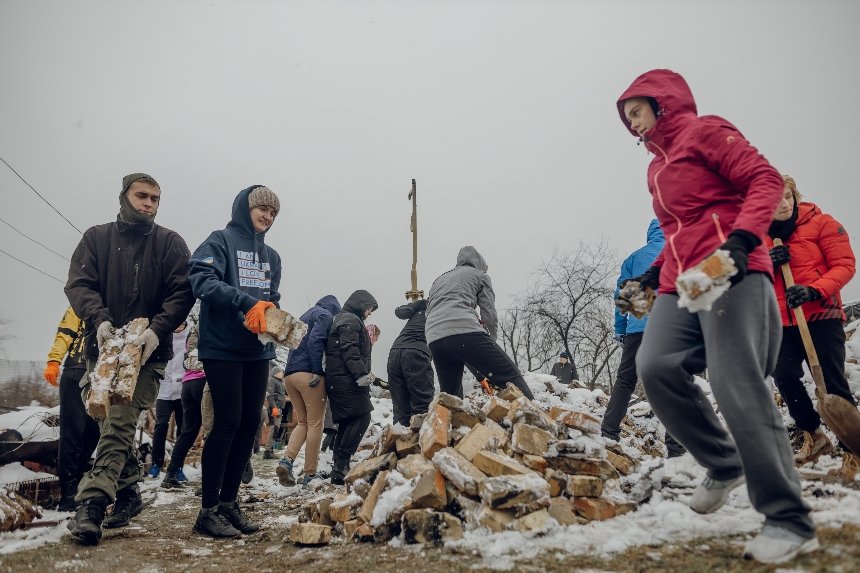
left=600, top=219, right=684, bottom=458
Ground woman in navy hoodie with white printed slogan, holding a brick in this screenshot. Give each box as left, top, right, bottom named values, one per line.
left=188, top=185, right=281, bottom=537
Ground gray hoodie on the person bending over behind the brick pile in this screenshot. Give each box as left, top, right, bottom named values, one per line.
left=425, top=247, right=498, bottom=344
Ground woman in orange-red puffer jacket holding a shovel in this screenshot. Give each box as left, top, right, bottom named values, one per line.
left=767, top=175, right=857, bottom=472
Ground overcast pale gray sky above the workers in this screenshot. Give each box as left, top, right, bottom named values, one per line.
left=0, top=0, right=860, bottom=366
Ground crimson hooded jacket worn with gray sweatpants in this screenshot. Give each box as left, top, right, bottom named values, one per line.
left=617, top=70, right=783, bottom=293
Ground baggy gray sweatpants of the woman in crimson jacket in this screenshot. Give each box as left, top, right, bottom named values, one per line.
left=636, top=273, right=815, bottom=538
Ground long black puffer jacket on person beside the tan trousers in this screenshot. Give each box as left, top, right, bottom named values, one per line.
left=325, top=290, right=378, bottom=422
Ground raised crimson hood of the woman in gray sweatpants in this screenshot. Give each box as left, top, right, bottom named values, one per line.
left=616, top=70, right=698, bottom=137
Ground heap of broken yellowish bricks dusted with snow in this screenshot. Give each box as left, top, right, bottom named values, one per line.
left=290, top=385, right=657, bottom=545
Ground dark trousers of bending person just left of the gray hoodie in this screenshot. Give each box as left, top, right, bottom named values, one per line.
left=388, top=348, right=435, bottom=428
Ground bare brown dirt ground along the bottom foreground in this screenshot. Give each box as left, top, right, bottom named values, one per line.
left=0, top=456, right=860, bottom=573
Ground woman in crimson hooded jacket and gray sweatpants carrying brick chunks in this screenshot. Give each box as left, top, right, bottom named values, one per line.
left=617, top=70, right=819, bottom=563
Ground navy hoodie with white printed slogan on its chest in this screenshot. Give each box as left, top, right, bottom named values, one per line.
left=188, top=185, right=281, bottom=361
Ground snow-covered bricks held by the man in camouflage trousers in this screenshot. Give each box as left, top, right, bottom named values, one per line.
left=86, top=318, right=149, bottom=419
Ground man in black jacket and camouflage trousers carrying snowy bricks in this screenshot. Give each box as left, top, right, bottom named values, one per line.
left=65, top=173, right=194, bottom=544
